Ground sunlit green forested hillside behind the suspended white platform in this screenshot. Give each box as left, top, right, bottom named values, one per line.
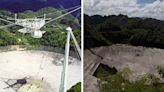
left=0, top=7, right=81, bottom=48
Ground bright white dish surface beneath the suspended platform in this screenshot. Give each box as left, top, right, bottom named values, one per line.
left=0, top=47, right=81, bottom=92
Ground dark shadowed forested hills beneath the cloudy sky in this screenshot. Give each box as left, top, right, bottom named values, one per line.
left=84, top=15, right=164, bottom=48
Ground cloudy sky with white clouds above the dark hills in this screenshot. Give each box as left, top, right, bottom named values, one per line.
left=84, top=0, right=164, bottom=20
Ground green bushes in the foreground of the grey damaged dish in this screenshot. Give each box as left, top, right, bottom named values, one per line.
left=99, top=70, right=164, bottom=92
